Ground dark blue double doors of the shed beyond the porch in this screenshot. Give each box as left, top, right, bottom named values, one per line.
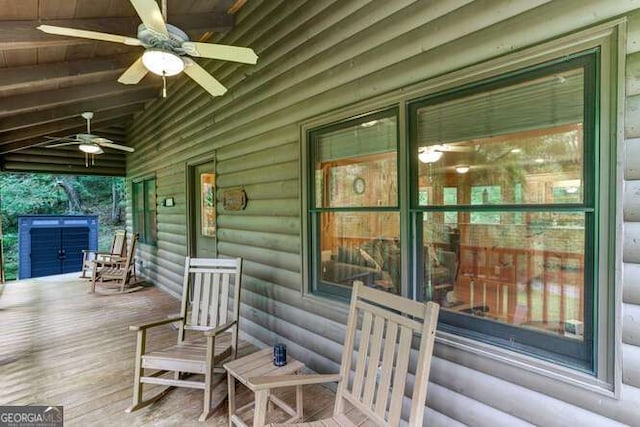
left=29, top=227, right=89, bottom=277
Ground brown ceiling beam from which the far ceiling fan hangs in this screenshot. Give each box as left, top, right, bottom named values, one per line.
left=0, top=85, right=158, bottom=133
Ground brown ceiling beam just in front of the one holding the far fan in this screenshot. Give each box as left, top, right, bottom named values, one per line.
left=0, top=81, right=156, bottom=118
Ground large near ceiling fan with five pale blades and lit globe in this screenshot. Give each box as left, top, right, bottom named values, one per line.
left=37, top=0, right=258, bottom=97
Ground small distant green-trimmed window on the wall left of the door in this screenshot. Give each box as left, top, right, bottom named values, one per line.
left=132, top=178, right=158, bottom=245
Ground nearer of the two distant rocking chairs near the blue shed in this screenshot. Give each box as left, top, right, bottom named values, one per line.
left=90, top=233, right=142, bottom=294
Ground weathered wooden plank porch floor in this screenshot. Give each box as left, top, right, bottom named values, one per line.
left=0, top=273, right=334, bottom=426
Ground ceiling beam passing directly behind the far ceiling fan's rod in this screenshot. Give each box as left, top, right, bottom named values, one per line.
left=0, top=104, right=140, bottom=145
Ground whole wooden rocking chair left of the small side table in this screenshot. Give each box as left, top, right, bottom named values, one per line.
left=126, top=257, right=242, bottom=421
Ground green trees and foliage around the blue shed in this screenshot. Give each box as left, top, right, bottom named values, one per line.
left=0, top=174, right=125, bottom=279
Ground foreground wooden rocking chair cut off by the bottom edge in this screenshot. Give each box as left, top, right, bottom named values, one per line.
left=249, top=284, right=439, bottom=427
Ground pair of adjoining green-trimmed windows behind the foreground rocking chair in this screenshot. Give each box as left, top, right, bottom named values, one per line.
left=305, top=48, right=612, bottom=378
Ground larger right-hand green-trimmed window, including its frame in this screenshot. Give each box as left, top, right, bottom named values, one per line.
left=408, top=50, right=602, bottom=372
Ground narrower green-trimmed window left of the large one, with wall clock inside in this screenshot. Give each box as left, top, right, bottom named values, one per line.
left=308, top=109, right=401, bottom=297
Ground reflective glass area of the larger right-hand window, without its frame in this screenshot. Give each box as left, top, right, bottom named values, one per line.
left=414, top=68, right=587, bottom=341
